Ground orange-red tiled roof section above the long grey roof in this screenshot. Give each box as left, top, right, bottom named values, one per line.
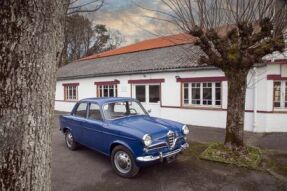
left=80, top=33, right=195, bottom=61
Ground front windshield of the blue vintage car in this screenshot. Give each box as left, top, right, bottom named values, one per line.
left=103, top=101, right=147, bottom=119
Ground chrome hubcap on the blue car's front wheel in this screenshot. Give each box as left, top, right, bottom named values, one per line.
left=114, top=151, right=132, bottom=174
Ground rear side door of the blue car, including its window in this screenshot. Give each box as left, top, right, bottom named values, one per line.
left=71, top=102, right=88, bottom=144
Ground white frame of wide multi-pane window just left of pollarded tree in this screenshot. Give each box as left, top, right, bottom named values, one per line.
left=182, top=81, right=223, bottom=108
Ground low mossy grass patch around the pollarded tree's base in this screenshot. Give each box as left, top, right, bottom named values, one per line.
left=200, top=143, right=262, bottom=169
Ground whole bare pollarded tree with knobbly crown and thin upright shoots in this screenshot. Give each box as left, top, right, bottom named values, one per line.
left=152, top=0, right=287, bottom=150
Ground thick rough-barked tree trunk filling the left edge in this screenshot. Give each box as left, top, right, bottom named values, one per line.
left=0, top=0, right=67, bottom=191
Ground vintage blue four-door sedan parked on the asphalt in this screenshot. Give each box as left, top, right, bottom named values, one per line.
left=60, top=98, right=189, bottom=177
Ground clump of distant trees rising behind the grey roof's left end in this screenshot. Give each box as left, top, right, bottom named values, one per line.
left=62, top=19, right=124, bottom=64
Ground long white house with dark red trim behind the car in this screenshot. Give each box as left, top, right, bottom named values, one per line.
left=55, top=34, right=287, bottom=132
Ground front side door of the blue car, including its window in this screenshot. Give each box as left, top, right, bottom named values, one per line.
left=83, top=103, right=106, bottom=152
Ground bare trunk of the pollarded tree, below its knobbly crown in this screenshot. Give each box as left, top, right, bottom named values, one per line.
left=225, top=71, right=248, bottom=149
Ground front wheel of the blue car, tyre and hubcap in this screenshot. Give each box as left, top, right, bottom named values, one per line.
left=111, top=145, right=140, bottom=178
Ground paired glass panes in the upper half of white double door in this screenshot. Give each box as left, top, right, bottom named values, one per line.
left=135, top=84, right=160, bottom=103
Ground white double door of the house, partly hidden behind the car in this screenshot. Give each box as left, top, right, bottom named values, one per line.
left=132, top=84, right=161, bottom=117
